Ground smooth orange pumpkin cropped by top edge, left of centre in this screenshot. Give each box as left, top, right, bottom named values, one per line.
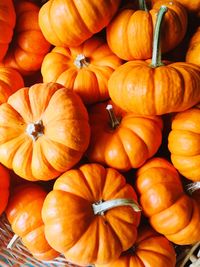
left=39, top=0, right=121, bottom=46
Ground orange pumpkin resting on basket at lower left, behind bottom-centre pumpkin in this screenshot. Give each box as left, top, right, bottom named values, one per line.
left=6, top=184, right=59, bottom=260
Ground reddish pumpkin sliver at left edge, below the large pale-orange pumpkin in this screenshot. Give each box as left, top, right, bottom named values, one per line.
left=0, top=164, right=10, bottom=215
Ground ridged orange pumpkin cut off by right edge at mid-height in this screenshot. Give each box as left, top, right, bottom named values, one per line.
left=168, top=108, right=200, bottom=181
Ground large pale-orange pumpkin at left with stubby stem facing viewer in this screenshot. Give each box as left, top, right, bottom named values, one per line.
left=0, top=83, right=90, bottom=181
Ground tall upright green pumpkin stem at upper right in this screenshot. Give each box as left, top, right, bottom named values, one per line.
left=151, top=5, right=168, bottom=68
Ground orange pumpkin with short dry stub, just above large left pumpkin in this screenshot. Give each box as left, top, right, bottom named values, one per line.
left=41, top=37, right=122, bottom=104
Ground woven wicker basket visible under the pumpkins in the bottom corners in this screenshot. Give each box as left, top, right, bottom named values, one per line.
left=0, top=215, right=200, bottom=267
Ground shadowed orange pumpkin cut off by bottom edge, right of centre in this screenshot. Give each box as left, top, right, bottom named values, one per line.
left=96, top=226, right=176, bottom=267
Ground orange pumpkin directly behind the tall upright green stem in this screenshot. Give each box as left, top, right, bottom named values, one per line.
left=106, top=0, right=187, bottom=60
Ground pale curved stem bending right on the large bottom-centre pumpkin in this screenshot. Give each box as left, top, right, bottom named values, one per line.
left=92, top=198, right=141, bottom=215
